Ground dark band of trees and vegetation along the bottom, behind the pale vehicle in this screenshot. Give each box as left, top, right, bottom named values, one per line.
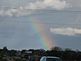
left=0, top=47, right=81, bottom=61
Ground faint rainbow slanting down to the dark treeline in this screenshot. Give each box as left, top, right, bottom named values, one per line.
left=31, top=17, right=55, bottom=50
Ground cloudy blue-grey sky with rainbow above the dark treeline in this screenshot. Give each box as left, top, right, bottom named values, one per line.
left=0, top=0, right=81, bottom=50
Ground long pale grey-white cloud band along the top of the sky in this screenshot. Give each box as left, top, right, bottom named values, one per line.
left=0, top=0, right=69, bottom=16
